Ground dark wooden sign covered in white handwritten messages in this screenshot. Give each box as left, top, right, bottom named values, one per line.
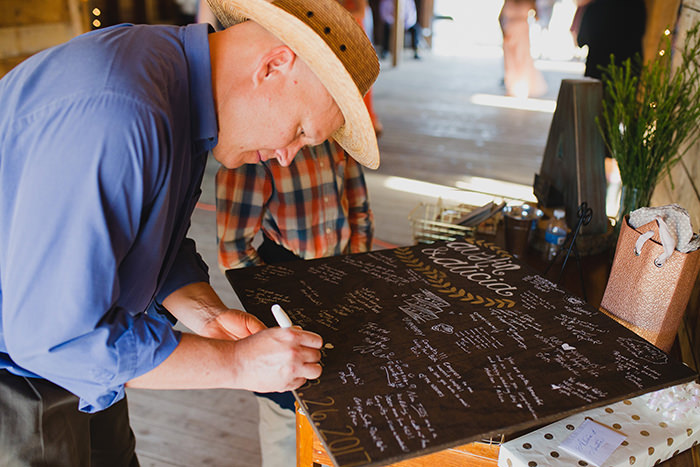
left=227, top=240, right=697, bottom=467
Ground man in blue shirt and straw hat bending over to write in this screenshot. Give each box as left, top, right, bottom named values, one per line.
left=0, top=0, right=379, bottom=466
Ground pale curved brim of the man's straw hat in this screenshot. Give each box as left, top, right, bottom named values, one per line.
left=209, top=0, right=379, bottom=169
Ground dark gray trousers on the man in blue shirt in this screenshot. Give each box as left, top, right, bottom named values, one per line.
left=0, top=370, right=139, bottom=467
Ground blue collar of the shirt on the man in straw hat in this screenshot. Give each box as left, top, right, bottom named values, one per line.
left=183, top=24, right=218, bottom=152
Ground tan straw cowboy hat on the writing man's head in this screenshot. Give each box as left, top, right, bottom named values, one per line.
left=208, top=0, right=379, bottom=169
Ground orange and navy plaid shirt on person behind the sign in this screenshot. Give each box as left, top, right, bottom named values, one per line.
left=216, top=141, right=373, bottom=270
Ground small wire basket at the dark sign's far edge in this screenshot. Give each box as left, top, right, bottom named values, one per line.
left=408, top=201, right=476, bottom=243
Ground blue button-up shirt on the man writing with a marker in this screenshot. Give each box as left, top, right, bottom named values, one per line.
left=0, top=25, right=217, bottom=412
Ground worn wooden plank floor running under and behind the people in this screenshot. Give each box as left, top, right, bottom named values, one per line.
left=127, top=49, right=578, bottom=467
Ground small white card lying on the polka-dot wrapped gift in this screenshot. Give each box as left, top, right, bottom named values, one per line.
left=561, top=418, right=626, bottom=466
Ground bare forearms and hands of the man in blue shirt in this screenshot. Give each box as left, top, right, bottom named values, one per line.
left=127, top=282, right=323, bottom=392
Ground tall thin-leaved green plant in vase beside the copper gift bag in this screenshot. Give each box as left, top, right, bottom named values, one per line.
left=597, top=23, right=700, bottom=225
